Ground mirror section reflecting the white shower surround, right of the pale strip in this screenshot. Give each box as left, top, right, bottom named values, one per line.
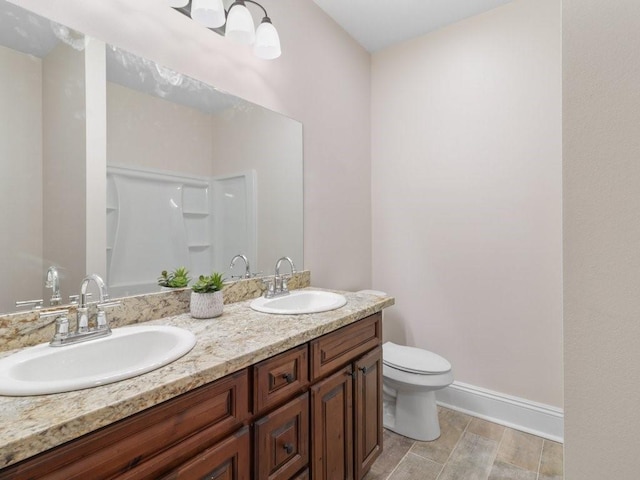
left=107, top=47, right=303, bottom=296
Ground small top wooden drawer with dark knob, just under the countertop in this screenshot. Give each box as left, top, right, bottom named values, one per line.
left=253, top=345, right=309, bottom=414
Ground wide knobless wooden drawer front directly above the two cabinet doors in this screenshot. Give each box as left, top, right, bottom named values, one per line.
left=311, top=313, right=382, bottom=380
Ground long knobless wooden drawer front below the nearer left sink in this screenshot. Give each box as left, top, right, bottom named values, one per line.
left=0, top=370, right=249, bottom=480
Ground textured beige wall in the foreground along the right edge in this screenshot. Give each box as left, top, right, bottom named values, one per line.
left=563, top=0, right=640, bottom=474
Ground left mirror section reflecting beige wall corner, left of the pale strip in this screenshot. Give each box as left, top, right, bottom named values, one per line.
left=0, top=1, right=85, bottom=312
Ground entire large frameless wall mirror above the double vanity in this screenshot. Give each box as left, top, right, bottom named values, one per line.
left=0, top=0, right=303, bottom=313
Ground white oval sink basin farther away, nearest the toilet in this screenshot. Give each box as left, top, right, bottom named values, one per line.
left=249, top=290, right=347, bottom=315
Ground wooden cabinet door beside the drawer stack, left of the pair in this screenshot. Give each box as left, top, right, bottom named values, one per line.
left=311, top=365, right=353, bottom=480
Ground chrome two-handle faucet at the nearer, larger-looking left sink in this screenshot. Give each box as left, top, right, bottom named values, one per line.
left=48, top=273, right=120, bottom=347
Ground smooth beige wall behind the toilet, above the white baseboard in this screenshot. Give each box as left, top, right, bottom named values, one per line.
left=372, top=0, right=562, bottom=407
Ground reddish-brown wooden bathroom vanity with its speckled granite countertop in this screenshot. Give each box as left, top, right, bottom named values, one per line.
left=0, top=292, right=393, bottom=479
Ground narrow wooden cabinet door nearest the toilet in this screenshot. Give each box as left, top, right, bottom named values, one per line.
left=354, top=347, right=382, bottom=480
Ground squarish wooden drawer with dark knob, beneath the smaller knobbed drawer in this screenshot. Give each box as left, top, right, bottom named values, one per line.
left=254, top=393, right=309, bottom=480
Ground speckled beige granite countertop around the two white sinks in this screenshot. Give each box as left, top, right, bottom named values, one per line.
left=0, top=292, right=394, bottom=468
